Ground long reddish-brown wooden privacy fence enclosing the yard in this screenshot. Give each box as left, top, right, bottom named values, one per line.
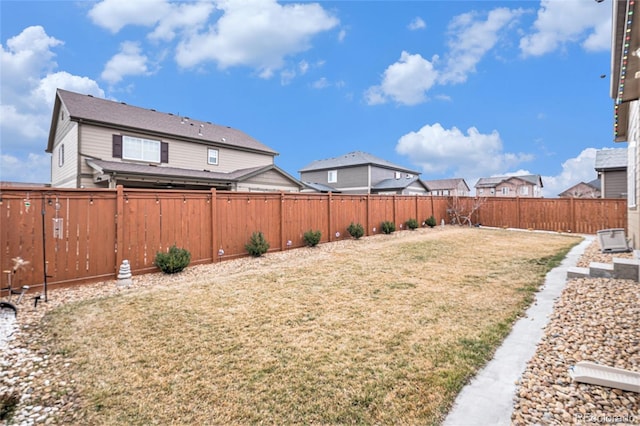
left=0, top=187, right=626, bottom=289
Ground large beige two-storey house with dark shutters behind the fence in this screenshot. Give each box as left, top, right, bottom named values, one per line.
left=46, top=89, right=303, bottom=192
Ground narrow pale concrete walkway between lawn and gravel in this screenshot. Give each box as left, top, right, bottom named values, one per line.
left=443, top=236, right=594, bottom=426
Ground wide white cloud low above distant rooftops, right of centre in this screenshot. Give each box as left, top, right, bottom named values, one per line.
left=396, top=123, right=533, bottom=178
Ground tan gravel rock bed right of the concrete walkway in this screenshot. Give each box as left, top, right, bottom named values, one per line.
left=512, top=248, right=640, bottom=425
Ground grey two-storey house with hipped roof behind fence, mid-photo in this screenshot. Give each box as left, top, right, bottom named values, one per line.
left=299, top=151, right=428, bottom=195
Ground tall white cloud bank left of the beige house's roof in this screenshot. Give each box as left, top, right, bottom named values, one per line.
left=0, top=26, right=104, bottom=182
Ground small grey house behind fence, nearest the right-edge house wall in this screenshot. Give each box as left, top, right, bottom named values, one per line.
left=595, top=148, right=627, bottom=198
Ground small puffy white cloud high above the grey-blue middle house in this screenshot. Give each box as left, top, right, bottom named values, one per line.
left=365, top=52, right=438, bottom=105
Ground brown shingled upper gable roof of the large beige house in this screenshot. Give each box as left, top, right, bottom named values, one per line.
left=46, top=89, right=278, bottom=155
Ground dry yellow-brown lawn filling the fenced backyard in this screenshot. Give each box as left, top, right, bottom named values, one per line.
left=44, top=227, right=580, bottom=424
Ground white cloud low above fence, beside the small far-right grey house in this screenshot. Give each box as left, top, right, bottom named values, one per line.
left=542, top=148, right=598, bottom=198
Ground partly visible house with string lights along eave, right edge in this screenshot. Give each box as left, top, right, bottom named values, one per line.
left=603, top=0, right=640, bottom=249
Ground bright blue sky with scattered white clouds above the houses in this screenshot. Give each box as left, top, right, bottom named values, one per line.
left=0, top=0, right=624, bottom=197
